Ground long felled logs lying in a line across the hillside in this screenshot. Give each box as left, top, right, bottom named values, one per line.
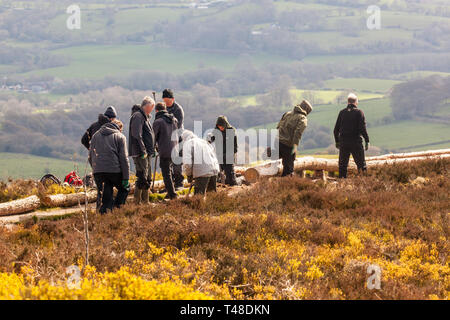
left=0, top=149, right=450, bottom=216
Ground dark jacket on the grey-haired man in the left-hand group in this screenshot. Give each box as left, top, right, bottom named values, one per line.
left=128, top=105, right=155, bottom=157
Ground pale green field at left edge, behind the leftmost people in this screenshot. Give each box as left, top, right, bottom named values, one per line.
left=0, top=153, right=85, bottom=180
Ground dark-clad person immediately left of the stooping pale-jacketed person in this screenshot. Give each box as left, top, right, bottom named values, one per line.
left=153, top=102, right=178, bottom=200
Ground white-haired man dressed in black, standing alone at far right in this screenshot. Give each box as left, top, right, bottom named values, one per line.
left=334, top=93, right=370, bottom=178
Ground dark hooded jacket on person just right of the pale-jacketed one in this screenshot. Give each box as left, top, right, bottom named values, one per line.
left=210, top=116, right=238, bottom=164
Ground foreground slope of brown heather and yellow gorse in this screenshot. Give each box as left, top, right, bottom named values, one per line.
left=0, top=160, right=450, bottom=299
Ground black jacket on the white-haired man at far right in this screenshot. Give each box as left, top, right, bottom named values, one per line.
left=334, top=104, right=369, bottom=143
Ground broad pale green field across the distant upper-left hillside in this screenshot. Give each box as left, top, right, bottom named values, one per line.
left=24, top=44, right=290, bottom=79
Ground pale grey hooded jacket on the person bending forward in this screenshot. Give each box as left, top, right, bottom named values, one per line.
left=181, top=130, right=220, bottom=179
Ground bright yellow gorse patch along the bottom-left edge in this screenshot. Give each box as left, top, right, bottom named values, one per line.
left=0, top=267, right=211, bottom=300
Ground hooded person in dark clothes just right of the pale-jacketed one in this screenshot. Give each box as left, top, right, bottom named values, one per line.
left=211, top=116, right=238, bottom=186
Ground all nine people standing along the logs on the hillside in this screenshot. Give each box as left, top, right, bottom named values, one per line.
left=81, top=89, right=369, bottom=214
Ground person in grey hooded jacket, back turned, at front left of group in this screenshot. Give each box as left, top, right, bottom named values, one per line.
left=89, top=120, right=130, bottom=214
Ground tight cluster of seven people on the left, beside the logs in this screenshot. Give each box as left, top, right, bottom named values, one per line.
left=81, top=89, right=238, bottom=214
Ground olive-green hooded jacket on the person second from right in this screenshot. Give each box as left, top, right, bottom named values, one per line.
left=277, top=106, right=308, bottom=147
